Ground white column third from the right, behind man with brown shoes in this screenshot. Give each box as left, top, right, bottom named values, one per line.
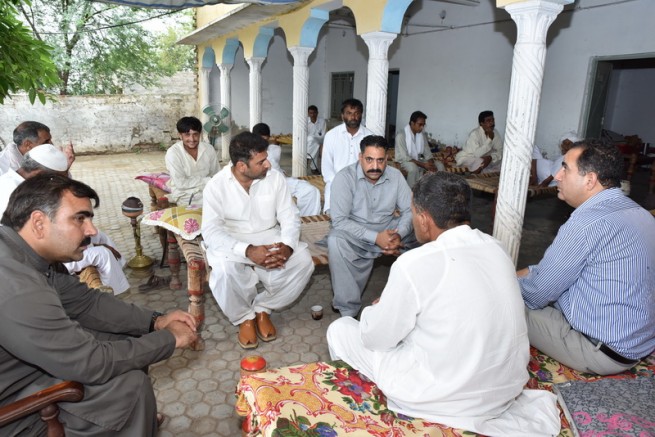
left=289, top=46, right=314, bottom=177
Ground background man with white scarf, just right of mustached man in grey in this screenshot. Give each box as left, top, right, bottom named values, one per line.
left=395, top=111, right=444, bottom=187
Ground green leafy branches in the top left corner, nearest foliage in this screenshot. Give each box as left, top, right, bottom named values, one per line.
left=0, top=0, right=59, bottom=104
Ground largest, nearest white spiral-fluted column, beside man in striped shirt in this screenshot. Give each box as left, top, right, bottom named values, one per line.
left=493, top=0, right=572, bottom=264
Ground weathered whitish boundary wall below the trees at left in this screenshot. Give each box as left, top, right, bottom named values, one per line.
left=0, top=72, right=199, bottom=154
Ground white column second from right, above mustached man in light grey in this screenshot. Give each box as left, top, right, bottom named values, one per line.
left=362, top=32, right=396, bottom=135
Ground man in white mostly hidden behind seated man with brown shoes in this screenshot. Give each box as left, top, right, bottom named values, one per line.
left=252, top=123, right=321, bottom=216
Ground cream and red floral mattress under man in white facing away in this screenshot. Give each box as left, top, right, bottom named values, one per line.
left=236, top=348, right=655, bottom=437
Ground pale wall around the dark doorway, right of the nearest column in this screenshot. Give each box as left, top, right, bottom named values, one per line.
left=536, top=0, right=655, bottom=153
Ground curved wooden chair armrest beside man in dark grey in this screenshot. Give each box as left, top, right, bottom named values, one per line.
left=0, top=381, right=84, bottom=437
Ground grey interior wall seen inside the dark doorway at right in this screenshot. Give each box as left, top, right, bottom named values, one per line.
left=605, top=68, right=655, bottom=143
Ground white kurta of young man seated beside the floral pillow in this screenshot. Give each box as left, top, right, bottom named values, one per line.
left=166, top=141, right=221, bottom=205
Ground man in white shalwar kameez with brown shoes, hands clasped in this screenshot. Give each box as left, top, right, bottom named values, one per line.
left=202, top=132, right=314, bottom=349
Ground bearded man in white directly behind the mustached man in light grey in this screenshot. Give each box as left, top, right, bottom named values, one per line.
left=321, top=99, right=373, bottom=213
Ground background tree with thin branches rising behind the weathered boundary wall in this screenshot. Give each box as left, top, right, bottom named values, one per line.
left=21, top=0, right=193, bottom=95
